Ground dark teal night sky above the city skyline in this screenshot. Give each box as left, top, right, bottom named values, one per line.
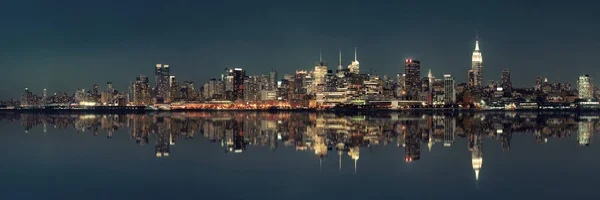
left=0, top=0, right=600, bottom=99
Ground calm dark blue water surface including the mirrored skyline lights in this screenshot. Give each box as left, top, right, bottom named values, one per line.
left=0, top=112, right=600, bottom=199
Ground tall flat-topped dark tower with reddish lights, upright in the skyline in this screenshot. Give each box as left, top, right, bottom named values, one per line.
left=404, top=59, right=421, bottom=100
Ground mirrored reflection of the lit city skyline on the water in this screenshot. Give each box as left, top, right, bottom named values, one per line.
left=0, top=112, right=599, bottom=184
